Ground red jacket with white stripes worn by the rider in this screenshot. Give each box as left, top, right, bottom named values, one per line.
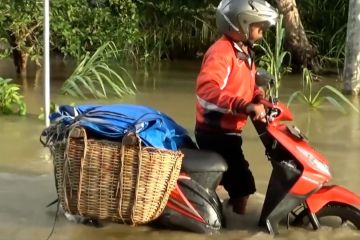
left=195, top=37, right=260, bottom=133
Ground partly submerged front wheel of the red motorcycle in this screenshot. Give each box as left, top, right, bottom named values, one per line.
left=292, top=203, right=360, bottom=230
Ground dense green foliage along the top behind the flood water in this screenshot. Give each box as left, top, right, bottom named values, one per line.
left=0, top=0, right=348, bottom=70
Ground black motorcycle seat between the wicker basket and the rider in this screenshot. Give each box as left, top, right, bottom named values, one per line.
left=180, top=148, right=228, bottom=173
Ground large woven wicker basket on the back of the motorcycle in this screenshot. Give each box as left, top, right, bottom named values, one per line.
left=53, top=127, right=183, bottom=224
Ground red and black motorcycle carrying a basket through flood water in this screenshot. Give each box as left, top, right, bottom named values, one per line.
left=157, top=70, right=360, bottom=234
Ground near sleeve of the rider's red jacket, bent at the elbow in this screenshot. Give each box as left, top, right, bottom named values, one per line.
left=196, top=54, right=248, bottom=114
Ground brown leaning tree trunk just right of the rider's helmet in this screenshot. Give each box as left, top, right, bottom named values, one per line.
left=276, top=0, right=321, bottom=73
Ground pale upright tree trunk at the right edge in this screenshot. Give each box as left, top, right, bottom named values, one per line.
left=344, top=0, right=360, bottom=95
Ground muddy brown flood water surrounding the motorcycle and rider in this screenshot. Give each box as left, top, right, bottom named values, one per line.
left=0, top=58, right=360, bottom=240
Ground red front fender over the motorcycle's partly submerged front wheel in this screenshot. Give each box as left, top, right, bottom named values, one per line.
left=306, top=185, right=360, bottom=213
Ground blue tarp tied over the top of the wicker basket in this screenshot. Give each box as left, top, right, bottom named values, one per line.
left=50, top=104, right=189, bottom=150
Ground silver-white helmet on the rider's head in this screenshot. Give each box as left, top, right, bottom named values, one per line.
left=216, top=0, right=278, bottom=42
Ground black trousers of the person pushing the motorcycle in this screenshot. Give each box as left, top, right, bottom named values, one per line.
left=195, top=130, right=256, bottom=198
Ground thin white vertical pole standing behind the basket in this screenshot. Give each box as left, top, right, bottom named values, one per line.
left=44, top=0, right=50, bottom=127
